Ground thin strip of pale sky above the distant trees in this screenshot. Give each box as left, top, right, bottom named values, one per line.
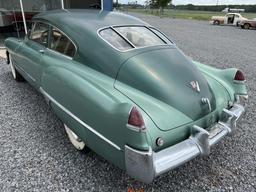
left=120, top=0, right=256, bottom=5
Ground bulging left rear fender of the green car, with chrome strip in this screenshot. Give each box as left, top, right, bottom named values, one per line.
left=40, top=65, right=151, bottom=168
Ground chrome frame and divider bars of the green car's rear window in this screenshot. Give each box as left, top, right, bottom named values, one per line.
left=97, top=24, right=175, bottom=53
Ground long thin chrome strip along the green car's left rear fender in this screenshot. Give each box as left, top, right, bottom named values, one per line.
left=39, top=87, right=121, bottom=151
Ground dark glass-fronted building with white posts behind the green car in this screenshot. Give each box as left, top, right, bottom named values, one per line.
left=0, top=0, right=113, bottom=32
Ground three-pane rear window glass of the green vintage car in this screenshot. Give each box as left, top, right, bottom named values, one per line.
left=100, top=26, right=170, bottom=51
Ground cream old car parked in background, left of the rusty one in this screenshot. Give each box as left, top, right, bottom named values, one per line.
left=210, top=13, right=247, bottom=26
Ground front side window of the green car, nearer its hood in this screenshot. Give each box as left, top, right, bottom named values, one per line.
left=29, top=22, right=49, bottom=47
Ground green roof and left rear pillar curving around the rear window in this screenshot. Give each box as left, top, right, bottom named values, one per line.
left=33, top=9, right=159, bottom=77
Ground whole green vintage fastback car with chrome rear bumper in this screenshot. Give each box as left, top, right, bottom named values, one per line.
left=5, top=10, right=248, bottom=183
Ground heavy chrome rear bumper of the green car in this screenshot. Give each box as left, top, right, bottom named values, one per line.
left=125, top=104, right=244, bottom=183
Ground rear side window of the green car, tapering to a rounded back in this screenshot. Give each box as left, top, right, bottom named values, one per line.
left=50, top=28, right=76, bottom=57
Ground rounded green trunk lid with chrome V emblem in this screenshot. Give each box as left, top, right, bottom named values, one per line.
left=115, top=48, right=215, bottom=130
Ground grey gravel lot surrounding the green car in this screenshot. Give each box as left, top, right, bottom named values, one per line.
left=0, top=12, right=256, bottom=192
